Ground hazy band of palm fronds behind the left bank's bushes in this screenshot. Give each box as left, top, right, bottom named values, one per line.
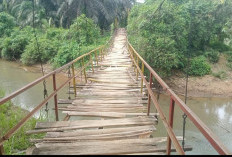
left=0, top=0, right=135, bottom=30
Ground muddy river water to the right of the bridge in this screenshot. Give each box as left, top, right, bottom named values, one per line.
left=150, top=95, right=232, bottom=155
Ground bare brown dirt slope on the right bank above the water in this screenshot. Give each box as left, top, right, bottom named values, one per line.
left=165, top=55, right=232, bottom=98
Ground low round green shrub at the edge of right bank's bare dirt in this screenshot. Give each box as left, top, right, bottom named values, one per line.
left=189, top=56, right=211, bottom=76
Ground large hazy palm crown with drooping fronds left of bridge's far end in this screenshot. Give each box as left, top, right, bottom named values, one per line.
left=41, top=0, right=135, bottom=29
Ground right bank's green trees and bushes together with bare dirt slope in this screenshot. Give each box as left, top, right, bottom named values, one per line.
left=127, top=0, right=232, bottom=97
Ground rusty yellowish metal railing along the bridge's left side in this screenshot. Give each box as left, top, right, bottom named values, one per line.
left=0, top=34, right=113, bottom=155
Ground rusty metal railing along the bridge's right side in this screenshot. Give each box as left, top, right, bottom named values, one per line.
left=127, top=41, right=231, bottom=155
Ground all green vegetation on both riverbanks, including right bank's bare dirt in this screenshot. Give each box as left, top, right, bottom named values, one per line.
left=0, top=0, right=232, bottom=97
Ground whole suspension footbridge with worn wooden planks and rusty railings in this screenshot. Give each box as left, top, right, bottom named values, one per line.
left=0, top=29, right=231, bottom=155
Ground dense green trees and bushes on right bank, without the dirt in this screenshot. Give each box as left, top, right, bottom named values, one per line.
left=127, top=0, right=232, bottom=77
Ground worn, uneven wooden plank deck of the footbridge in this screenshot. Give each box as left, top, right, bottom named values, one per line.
left=27, top=27, right=186, bottom=155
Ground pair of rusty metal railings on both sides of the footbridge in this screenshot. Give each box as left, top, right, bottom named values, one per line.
left=0, top=29, right=231, bottom=155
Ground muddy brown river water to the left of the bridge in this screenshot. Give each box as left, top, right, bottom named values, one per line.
left=0, top=60, right=67, bottom=119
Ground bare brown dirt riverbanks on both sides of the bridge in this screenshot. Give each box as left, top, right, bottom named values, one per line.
left=1, top=55, right=232, bottom=98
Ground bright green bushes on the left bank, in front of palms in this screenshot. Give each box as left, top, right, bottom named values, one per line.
left=0, top=13, right=109, bottom=67
